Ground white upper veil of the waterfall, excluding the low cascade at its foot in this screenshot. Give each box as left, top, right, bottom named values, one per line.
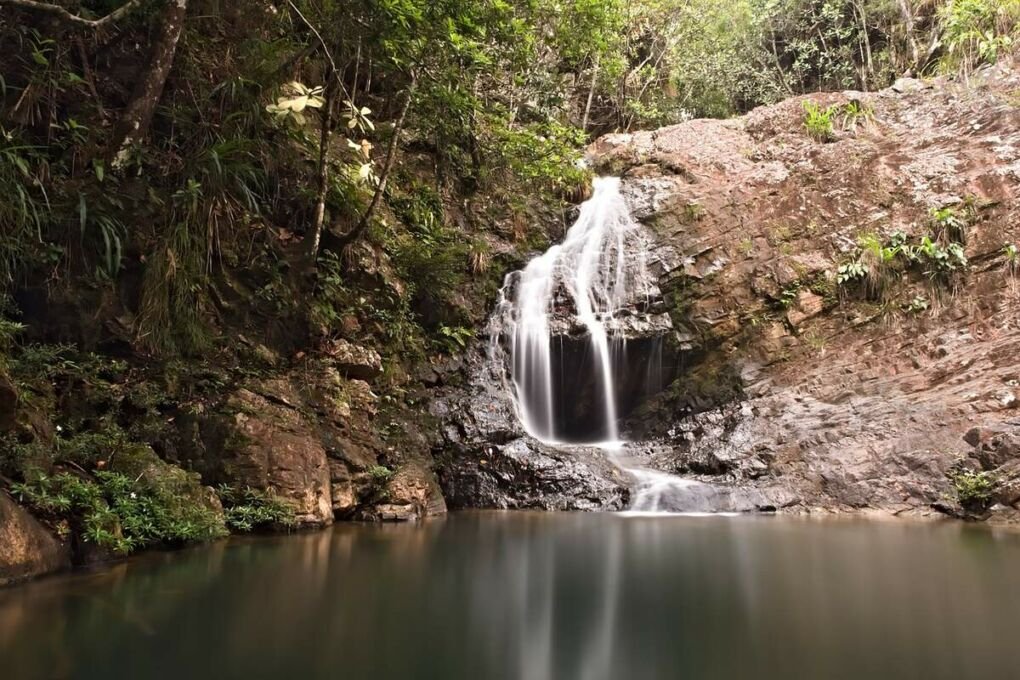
left=490, top=177, right=651, bottom=444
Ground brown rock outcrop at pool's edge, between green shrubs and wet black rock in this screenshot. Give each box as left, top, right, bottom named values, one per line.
left=169, top=367, right=446, bottom=527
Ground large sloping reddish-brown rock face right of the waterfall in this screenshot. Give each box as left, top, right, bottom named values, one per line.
left=592, top=65, right=1020, bottom=514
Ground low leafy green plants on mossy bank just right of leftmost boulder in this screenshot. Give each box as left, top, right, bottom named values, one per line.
left=11, top=471, right=225, bottom=555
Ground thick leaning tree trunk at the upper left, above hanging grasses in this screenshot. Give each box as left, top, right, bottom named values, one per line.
left=107, top=0, right=188, bottom=169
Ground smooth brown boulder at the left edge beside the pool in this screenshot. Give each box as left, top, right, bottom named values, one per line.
left=0, top=491, right=70, bottom=586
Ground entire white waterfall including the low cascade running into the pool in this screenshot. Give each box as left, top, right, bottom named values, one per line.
left=489, top=177, right=726, bottom=513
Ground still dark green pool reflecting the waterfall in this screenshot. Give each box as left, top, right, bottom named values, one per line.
left=0, top=513, right=1020, bottom=680
